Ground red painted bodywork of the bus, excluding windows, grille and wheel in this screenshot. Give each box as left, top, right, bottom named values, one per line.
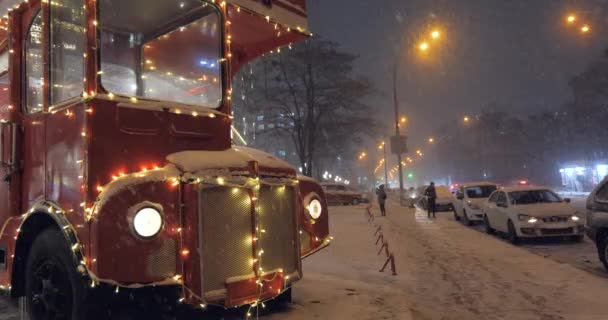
left=0, top=0, right=329, bottom=306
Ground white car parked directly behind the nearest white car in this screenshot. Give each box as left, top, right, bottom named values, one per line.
left=454, top=182, right=498, bottom=226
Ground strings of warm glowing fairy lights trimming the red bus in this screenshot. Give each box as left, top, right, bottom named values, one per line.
left=0, top=0, right=318, bottom=317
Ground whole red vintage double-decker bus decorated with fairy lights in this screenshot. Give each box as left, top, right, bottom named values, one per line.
left=0, top=0, right=330, bottom=319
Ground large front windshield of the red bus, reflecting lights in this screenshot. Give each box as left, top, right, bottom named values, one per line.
left=99, top=0, right=222, bottom=108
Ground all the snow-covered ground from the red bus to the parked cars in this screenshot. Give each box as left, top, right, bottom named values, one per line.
left=0, top=201, right=608, bottom=320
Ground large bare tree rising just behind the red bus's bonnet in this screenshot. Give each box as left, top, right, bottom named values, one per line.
left=233, top=39, right=377, bottom=176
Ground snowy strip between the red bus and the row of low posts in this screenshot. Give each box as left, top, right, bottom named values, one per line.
left=268, top=206, right=415, bottom=320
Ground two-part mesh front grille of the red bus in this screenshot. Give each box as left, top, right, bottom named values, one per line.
left=199, top=184, right=299, bottom=301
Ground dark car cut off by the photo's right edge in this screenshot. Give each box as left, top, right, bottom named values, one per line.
left=587, top=177, right=608, bottom=270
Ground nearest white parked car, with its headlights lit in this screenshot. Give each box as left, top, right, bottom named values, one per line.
left=484, top=187, right=585, bottom=244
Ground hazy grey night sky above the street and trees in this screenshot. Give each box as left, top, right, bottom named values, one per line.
left=308, top=0, right=608, bottom=142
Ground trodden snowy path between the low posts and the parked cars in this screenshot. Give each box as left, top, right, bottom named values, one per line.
left=374, top=202, right=608, bottom=320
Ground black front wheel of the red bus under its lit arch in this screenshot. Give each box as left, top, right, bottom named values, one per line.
left=25, top=229, right=88, bottom=320
